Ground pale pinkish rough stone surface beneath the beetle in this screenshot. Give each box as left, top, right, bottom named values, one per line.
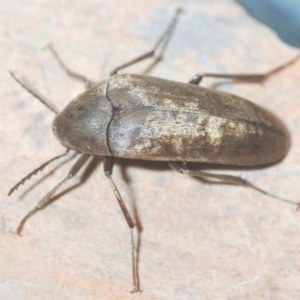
left=0, top=0, right=300, bottom=299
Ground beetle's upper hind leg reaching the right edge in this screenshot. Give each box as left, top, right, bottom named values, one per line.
left=189, top=54, right=300, bottom=85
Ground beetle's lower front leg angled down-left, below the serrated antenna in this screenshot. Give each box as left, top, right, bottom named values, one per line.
left=17, top=154, right=90, bottom=235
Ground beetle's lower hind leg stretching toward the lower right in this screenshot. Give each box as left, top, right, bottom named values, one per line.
left=169, top=162, right=299, bottom=206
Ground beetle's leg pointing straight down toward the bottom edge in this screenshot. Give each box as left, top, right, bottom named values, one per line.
left=103, top=157, right=141, bottom=293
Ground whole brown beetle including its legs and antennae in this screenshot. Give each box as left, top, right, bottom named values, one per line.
left=9, top=10, right=299, bottom=292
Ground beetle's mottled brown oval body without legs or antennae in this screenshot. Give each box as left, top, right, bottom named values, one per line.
left=53, top=74, right=290, bottom=166
